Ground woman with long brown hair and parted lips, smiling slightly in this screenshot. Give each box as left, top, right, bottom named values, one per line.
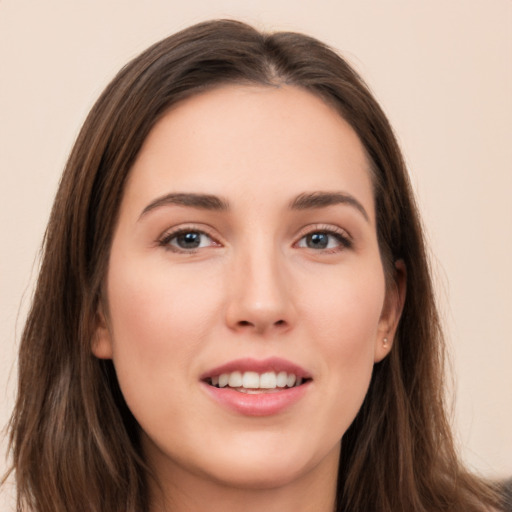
left=4, top=21, right=499, bottom=512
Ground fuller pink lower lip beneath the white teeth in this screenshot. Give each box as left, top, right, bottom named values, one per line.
left=202, top=381, right=311, bottom=416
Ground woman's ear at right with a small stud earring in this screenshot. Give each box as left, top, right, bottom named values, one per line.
left=374, top=260, right=407, bottom=363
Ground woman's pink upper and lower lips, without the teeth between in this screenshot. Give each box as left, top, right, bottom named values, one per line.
left=201, top=358, right=311, bottom=416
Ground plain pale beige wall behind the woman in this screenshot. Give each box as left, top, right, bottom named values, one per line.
left=0, top=0, right=512, bottom=504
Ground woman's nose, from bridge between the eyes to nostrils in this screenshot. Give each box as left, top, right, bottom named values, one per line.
left=226, top=244, right=296, bottom=335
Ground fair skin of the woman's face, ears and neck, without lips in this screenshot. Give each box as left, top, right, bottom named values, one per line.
left=92, top=85, right=404, bottom=512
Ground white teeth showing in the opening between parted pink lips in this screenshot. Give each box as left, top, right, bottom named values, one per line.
left=204, top=370, right=311, bottom=394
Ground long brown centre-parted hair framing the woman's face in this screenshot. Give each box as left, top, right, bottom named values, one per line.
left=4, top=21, right=504, bottom=512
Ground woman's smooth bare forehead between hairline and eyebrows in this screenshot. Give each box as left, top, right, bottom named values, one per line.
left=122, top=85, right=373, bottom=217
